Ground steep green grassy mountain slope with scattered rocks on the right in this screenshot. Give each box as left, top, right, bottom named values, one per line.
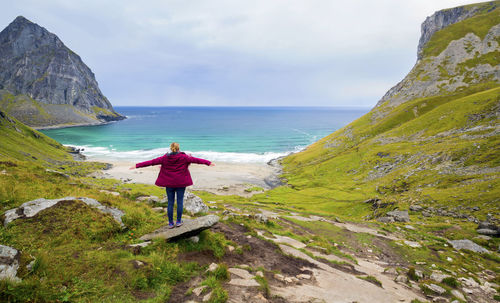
left=274, top=1, right=500, bottom=220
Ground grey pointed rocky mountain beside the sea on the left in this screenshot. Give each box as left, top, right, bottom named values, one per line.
left=0, top=16, right=124, bottom=127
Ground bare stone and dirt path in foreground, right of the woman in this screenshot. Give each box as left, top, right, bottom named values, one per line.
left=174, top=206, right=426, bottom=302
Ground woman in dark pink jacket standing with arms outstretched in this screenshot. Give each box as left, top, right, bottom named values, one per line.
left=130, top=142, right=215, bottom=228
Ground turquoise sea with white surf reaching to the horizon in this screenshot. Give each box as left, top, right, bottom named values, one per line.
left=42, top=107, right=369, bottom=163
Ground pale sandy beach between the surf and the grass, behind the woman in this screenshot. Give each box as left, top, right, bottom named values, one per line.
left=89, top=159, right=280, bottom=196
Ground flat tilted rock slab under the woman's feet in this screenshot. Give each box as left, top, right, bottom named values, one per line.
left=139, top=215, right=219, bottom=241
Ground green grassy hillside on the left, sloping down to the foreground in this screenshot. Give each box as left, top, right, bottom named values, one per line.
left=0, top=112, right=227, bottom=302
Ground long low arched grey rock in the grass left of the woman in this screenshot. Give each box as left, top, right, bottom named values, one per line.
left=4, top=197, right=125, bottom=228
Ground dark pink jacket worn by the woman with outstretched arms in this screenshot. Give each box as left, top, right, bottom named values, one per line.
left=135, top=152, right=211, bottom=187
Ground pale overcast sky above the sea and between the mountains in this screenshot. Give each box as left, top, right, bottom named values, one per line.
left=0, top=0, right=477, bottom=107
